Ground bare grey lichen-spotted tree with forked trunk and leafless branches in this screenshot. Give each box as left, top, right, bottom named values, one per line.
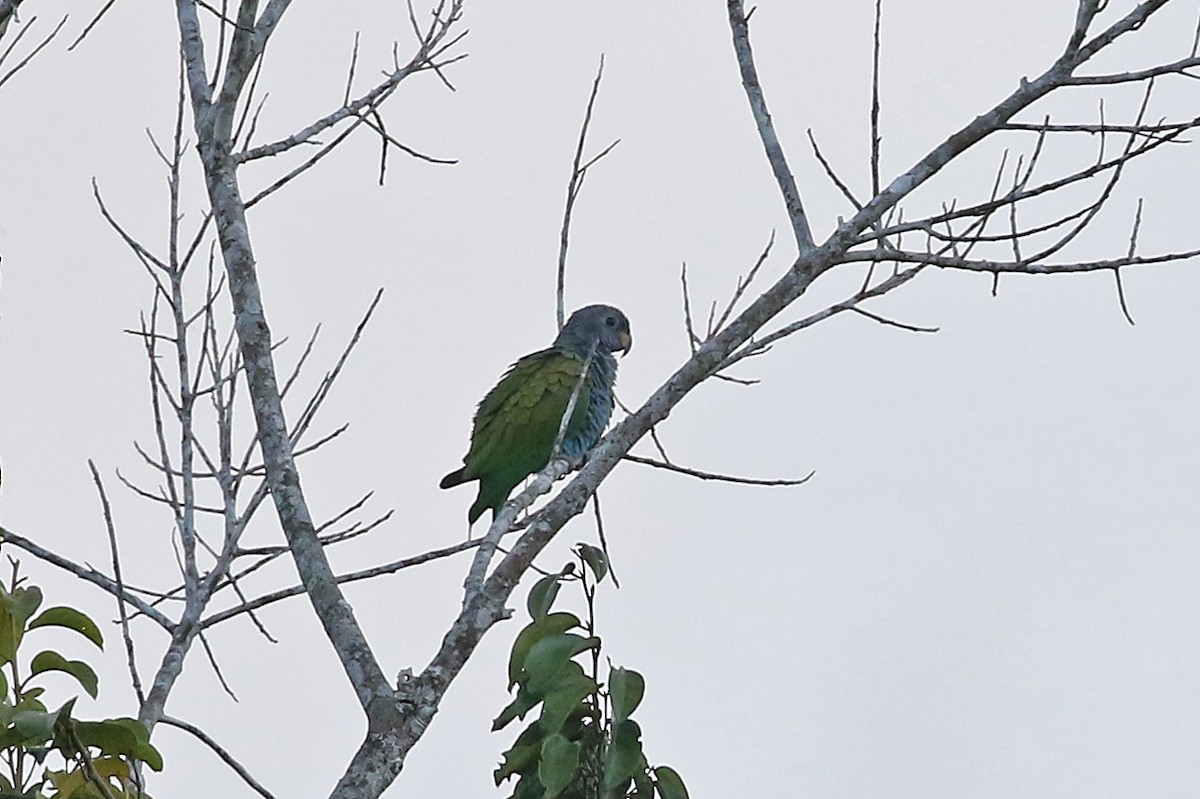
left=56, top=0, right=1200, bottom=799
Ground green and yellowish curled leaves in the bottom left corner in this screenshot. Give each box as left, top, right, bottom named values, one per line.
left=0, top=561, right=162, bottom=799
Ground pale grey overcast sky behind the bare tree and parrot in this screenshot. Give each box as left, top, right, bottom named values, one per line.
left=0, top=0, right=1200, bottom=799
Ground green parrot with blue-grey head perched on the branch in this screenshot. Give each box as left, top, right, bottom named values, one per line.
left=439, top=305, right=634, bottom=524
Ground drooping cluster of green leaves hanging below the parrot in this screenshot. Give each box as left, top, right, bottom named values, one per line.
left=492, top=545, right=688, bottom=799
